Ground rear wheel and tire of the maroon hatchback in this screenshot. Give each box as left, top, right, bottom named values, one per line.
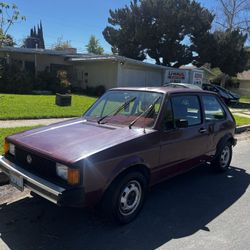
left=212, top=142, right=233, bottom=172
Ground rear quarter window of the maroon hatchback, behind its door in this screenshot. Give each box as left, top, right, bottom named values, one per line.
left=202, top=95, right=225, bottom=121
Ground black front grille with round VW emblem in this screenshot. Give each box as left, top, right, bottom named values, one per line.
left=15, top=147, right=57, bottom=179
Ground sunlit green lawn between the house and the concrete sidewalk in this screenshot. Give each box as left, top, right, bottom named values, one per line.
left=0, top=94, right=96, bottom=120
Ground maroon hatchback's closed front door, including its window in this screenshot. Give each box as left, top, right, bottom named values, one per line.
left=150, top=94, right=209, bottom=184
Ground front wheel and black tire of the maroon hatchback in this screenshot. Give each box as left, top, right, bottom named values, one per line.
left=102, top=171, right=148, bottom=224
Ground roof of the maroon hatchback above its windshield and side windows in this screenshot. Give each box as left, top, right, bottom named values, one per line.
left=110, top=86, right=207, bottom=94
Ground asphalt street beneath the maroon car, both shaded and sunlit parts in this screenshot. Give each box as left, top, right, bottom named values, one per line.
left=0, top=133, right=250, bottom=250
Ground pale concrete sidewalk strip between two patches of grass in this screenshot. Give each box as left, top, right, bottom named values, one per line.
left=0, top=117, right=74, bottom=128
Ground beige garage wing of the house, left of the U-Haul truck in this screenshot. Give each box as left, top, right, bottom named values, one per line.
left=67, top=54, right=166, bottom=89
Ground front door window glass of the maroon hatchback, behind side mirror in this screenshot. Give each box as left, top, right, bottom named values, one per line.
left=171, top=95, right=201, bottom=127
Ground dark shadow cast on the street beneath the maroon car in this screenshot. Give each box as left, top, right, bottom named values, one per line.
left=0, top=167, right=250, bottom=249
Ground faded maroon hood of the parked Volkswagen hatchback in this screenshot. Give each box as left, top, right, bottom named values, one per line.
left=8, top=118, right=144, bottom=163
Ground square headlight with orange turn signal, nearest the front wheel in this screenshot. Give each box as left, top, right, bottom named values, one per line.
left=56, top=163, right=80, bottom=185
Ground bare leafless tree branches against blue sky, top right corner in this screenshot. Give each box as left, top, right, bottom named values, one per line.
left=216, top=0, right=250, bottom=35
